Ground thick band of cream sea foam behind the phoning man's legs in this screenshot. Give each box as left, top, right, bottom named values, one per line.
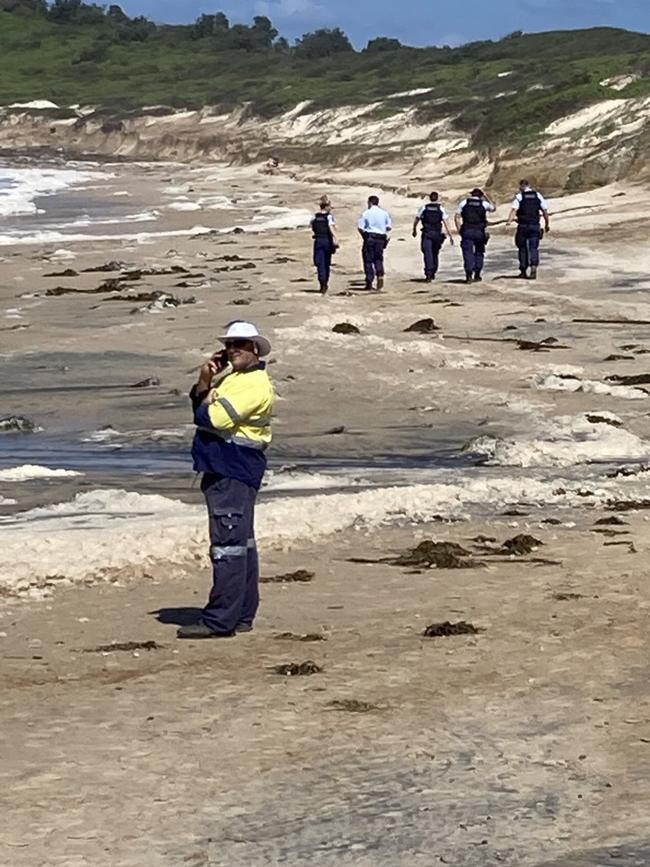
left=0, top=474, right=630, bottom=594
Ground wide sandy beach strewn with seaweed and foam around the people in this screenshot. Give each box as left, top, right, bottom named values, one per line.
left=0, top=163, right=650, bottom=867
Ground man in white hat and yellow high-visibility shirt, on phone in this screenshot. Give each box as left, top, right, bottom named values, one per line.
left=177, top=321, right=274, bottom=638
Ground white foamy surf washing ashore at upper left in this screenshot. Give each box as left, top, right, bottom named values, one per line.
left=0, top=162, right=312, bottom=247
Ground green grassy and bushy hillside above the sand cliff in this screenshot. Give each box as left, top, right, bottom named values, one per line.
left=0, top=0, right=650, bottom=148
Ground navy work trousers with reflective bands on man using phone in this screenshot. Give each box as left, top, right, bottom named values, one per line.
left=201, top=473, right=259, bottom=633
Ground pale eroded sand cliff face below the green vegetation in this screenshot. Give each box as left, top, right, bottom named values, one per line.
left=0, top=94, right=650, bottom=195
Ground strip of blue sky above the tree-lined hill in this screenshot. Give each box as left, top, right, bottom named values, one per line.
left=124, top=0, right=650, bottom=47
